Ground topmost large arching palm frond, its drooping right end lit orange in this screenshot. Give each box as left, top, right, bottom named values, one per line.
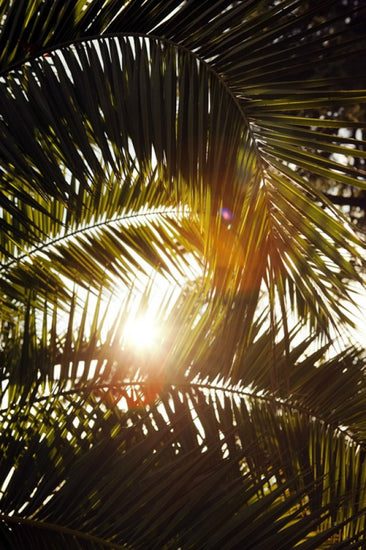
left=2, top=33, right=359, bottom=336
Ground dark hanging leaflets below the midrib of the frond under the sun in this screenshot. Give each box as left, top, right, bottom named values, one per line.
left=2, top=322, right=365, bottom=548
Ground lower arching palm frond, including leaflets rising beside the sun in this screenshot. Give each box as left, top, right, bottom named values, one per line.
left=1, top=276, right=365, bottom=548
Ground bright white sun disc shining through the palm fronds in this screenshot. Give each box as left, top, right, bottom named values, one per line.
left=125, top=313, right=161, bottom=351
